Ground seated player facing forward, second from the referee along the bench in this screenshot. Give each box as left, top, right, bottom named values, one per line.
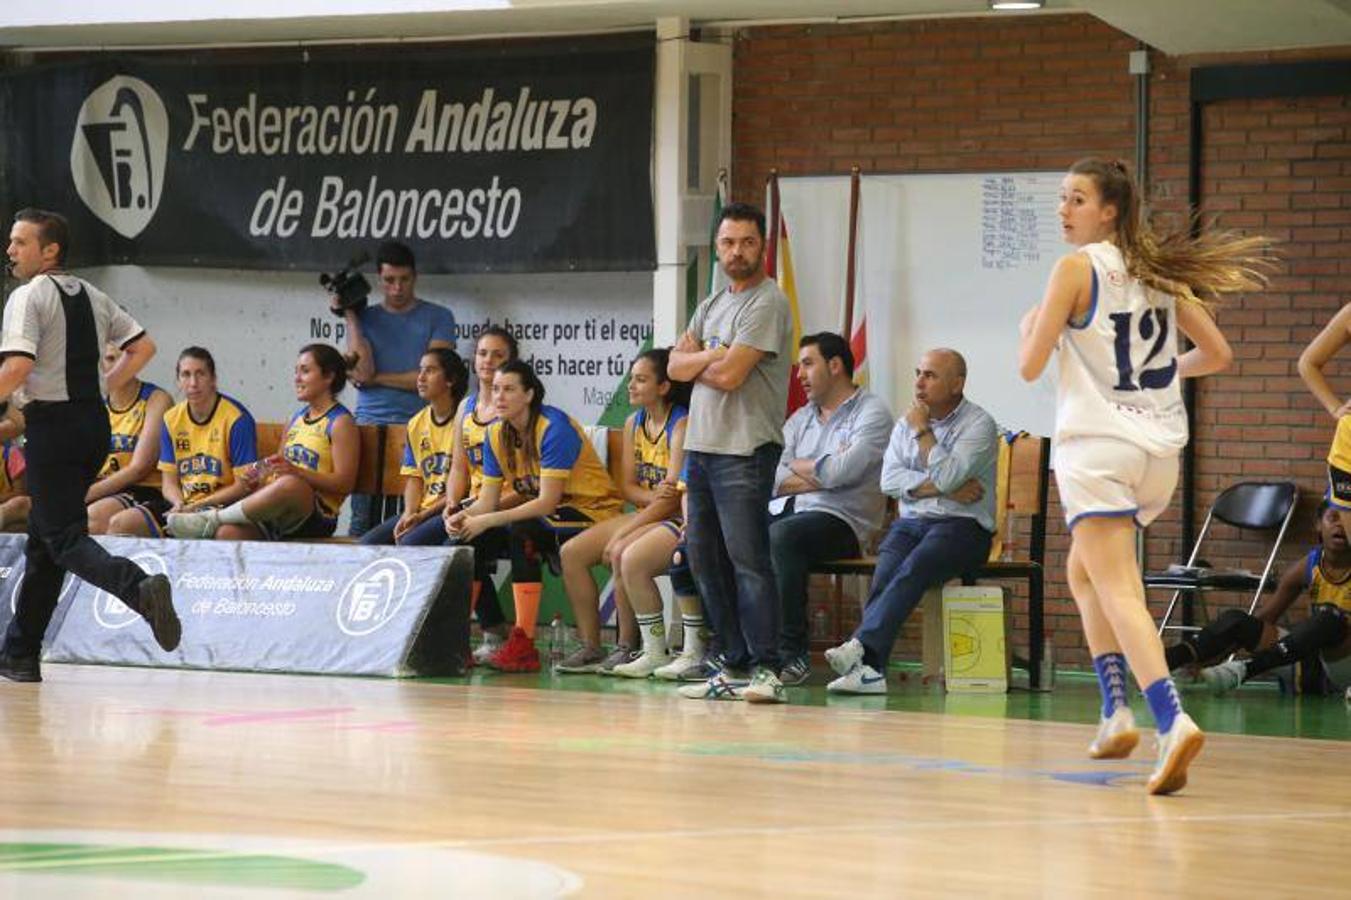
left=108, top=347, right=258, bottom=538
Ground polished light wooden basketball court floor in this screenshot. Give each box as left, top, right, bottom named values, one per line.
left=0, top=665, right=1351, bottom=900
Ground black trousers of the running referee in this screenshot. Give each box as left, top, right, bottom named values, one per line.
left=4, top=400, right=146, bottom=657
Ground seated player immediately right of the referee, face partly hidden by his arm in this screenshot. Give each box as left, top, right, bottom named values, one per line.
left=85, top=345, right=173, bottom=534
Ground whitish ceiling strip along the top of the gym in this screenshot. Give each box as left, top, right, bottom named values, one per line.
left=0, top=0, right=1351, bottom=54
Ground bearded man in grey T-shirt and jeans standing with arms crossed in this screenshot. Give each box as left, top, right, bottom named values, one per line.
left=667, top=203, right=793, bottom=703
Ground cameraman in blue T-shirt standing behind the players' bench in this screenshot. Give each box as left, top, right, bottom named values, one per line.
left=332, top=241, right=455, bottom=538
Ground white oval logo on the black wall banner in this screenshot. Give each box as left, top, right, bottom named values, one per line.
left=70, top=76, right=169, bottom=238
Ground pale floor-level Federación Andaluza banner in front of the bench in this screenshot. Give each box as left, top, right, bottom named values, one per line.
left=21, top=536, right=474, bottom=677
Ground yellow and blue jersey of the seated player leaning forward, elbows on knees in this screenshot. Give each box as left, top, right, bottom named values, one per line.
left=484, top=405, right=624, bottom=522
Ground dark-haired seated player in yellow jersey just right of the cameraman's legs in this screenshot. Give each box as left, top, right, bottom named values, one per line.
left=361, top=347, right=469, bottom=546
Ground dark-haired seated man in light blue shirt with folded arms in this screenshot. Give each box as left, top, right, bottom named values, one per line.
left=769, top=331, right=892, bottom=685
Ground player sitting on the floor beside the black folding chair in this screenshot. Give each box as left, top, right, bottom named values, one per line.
left=1166, top=500, right=1351, bottom=692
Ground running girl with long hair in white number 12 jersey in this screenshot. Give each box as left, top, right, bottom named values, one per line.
left=1019, top=158, right=1270, bottom=793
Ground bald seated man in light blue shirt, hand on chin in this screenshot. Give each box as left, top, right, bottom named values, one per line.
left=825, top=349, right=998, bottom=693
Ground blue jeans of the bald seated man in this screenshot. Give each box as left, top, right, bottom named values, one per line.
left=854, top=516, right=994, bottom=672
